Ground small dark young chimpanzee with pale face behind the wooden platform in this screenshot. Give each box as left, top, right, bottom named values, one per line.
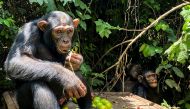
left=133, top=70, right=161, bottom=103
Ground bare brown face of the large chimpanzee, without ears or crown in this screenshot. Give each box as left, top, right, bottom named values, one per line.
left=52, top=24, right=74, bottom=54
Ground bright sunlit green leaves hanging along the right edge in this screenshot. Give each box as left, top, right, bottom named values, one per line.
left=165, top=6, right=190, bottom=64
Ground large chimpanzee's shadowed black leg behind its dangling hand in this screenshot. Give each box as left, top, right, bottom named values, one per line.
left=75, top=71, right=92, bottom=109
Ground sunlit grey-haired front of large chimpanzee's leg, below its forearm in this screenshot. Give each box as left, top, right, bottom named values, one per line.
left=32, top=82, right=60, bottom=109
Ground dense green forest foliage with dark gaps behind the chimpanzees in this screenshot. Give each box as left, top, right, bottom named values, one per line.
left=0, top=0, right=190, bottom=108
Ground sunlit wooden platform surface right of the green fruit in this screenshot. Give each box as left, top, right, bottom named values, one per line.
left=95, top=92, right=163, bottom=109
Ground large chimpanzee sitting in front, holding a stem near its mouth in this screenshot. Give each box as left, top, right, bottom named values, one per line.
left=5, top=11, right=91, bottom=109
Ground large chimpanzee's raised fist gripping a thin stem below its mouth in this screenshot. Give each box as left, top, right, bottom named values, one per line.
left=65, top=52, right=83, bottom=71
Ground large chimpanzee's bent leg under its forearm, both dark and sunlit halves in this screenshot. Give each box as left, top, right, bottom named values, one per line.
left=16, top=82, right=60, bottom=109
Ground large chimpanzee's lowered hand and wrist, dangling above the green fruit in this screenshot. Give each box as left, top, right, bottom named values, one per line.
left=52, top=64, right=87, bottom=98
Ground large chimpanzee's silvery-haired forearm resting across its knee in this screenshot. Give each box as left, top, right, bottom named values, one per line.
left=6, top=55, right=78, bottom=86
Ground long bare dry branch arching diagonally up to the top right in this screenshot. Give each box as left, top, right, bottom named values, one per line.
left=102, top=2, right=190, bottom=90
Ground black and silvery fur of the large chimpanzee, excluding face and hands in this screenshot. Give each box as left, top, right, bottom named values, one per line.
left=4, top=11, right=91, bottom=109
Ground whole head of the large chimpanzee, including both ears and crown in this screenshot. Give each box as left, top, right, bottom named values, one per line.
left=37, top=11, right=79, bottom=54
